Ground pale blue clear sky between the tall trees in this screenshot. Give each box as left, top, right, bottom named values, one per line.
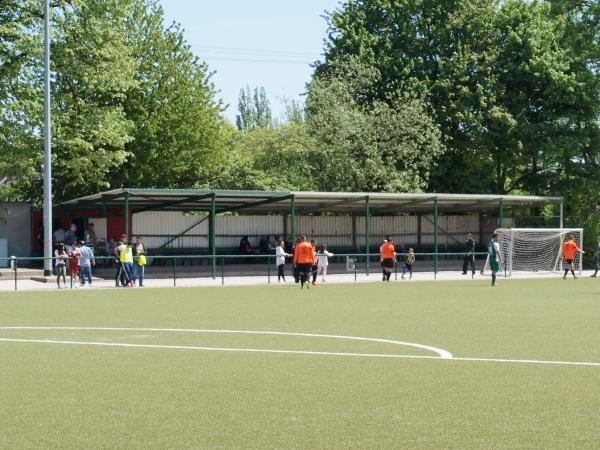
left=160, top=0, right=339, bottom=122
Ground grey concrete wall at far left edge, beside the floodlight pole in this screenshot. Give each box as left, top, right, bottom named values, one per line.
left=0, top=203, right=31, bottom=256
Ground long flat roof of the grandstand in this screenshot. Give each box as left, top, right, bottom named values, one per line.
left=55, top=188, right=563, bottom=214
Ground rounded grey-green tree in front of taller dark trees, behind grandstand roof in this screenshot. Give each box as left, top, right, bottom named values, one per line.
left=307, top=57, right=444, bottom=192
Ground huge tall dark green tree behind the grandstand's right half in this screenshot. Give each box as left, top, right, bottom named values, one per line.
left=317, top=0, right=598, bottom=197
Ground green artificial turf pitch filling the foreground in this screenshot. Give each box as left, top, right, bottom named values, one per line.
left=0, top=279, right=600, bottom=449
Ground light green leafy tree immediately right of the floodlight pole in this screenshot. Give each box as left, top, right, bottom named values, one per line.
left=52, top=0, right=137, bottom=200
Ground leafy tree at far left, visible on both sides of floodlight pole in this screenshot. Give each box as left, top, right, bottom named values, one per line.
left=0, top=0, right=135, bottom=201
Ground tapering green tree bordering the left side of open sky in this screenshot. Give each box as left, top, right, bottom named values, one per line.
left=120, top=0, right=224, bottom=188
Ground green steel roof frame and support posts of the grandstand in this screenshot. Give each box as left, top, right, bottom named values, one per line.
left=56, top=185, right=564, bottom=277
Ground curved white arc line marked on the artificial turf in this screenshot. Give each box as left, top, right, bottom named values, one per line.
left=0, top=327, right=452, bottom=359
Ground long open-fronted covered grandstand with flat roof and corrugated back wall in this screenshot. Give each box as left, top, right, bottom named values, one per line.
left=50, top=188, right=564, bottom=275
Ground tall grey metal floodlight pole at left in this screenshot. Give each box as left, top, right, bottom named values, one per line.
left=44, top=0, right=52, bottom=276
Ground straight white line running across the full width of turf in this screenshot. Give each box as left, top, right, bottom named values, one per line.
left=0, top=338, right=600, bottom=367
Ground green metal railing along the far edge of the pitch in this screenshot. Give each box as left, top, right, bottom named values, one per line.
left=0, top=252, right=487, bottom=290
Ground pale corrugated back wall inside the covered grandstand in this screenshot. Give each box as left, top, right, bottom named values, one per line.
left=133, top=212, right=488, bottom=250
